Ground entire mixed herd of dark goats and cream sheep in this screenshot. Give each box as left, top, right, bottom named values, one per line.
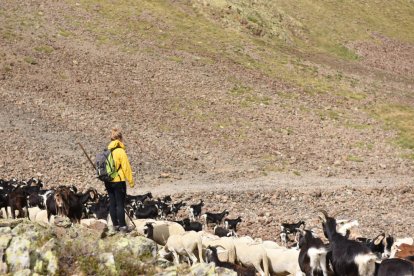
left=0, top=178, right=414, bottom=276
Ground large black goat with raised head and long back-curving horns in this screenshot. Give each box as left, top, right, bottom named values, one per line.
left=320, top=210, right=376, bottom=276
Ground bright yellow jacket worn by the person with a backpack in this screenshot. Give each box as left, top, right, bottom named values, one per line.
left=108, top=140, right=135, bottom=188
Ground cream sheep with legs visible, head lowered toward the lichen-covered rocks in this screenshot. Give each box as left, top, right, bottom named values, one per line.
left=161, top=231, right=204, bottom=265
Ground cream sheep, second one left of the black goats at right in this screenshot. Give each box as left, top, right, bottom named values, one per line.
left=234, top=239, right=269, bottom=276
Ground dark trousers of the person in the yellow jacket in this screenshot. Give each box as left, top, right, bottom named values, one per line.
left=105, top=181, right=126, bottom=227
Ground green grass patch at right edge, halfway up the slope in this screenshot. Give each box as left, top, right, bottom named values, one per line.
left=374, top=104, right=414, bottom=150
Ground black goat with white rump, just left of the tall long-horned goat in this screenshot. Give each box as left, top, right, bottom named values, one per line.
left=299, top=229, right=328, bottom=276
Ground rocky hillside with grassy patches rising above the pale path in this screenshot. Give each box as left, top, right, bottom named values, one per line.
left=0, top=0, right=414, bottom=190
